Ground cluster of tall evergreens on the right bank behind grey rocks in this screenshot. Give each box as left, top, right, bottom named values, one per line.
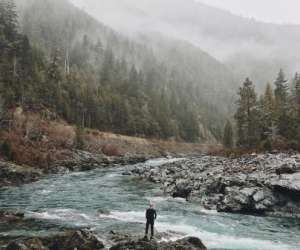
left=223, top=70, right=300, bottom=150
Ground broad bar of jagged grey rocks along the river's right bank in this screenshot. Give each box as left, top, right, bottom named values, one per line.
left=128, top=153, right=300, bottom=217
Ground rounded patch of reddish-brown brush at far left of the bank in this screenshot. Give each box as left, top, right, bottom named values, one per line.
left=0, top=108, right=75, bottom=168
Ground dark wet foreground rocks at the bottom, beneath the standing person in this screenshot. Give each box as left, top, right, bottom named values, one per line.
left=0, top=211, right=207, bottom=250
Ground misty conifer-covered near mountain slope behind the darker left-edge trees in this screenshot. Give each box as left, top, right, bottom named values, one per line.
left=12, top=0, right=236, bottom=142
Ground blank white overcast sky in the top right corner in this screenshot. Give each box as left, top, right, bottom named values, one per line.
left=196, top=0, right=300, bottom=24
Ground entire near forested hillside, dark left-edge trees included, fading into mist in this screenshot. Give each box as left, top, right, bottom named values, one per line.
left=1, top=0, right=239, bottom=142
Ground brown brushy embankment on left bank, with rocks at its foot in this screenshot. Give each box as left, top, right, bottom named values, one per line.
left=0, top=107, right=218, bottom=188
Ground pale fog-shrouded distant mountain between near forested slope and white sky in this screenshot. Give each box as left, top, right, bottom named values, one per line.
left=72, top=0, right=300, bottom=87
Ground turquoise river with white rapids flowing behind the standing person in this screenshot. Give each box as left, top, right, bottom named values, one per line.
left=0, top=160, right=300, bottom=250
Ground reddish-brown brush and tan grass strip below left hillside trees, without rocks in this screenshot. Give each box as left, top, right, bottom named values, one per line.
left=0, top=108, right=220, bottom=168
